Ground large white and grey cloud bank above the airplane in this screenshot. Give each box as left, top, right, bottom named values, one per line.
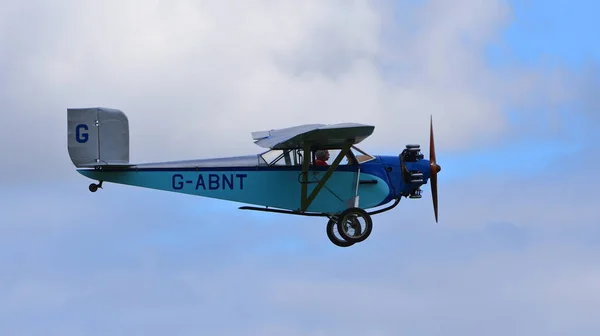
left=0, top=0, right=592, bottom=175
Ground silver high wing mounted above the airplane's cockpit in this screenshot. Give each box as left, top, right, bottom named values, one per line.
left=252, top=123, right=375, bottom=149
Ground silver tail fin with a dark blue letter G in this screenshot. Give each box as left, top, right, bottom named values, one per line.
left=67, top=107, right=130, bottom=168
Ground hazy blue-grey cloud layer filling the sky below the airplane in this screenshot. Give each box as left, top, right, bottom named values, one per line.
left=0, top=150, right=600, bottom=335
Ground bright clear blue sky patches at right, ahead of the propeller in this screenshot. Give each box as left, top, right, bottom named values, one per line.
left=438, top=0, right=600, bottom=178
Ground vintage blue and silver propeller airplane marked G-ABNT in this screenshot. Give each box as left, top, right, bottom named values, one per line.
left=67, top=107, right=441, bottom=247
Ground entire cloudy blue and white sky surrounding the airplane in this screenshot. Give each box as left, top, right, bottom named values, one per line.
left=0, top=0, right=600, bottom=335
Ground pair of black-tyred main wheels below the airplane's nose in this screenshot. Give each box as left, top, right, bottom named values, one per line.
left=327, top=208, right=373, bottom=247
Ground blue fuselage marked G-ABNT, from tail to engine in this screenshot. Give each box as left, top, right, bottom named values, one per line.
left=78, top=155, right=429, bottom=213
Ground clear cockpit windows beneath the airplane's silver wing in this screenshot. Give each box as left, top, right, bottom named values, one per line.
left=259, top=146, right=375, bottom=166
